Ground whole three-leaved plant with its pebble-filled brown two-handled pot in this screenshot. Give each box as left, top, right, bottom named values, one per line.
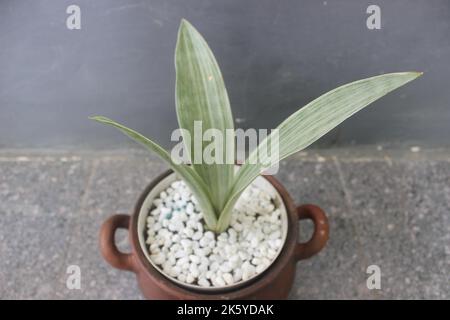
left=92, top=20, right=421, bottom=299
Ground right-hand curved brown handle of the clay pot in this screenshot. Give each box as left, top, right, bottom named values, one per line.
left=295, top=204, right=329, bottom=260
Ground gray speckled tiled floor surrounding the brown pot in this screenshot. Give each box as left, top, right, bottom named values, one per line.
left=0, top=148, right=450, bottom=299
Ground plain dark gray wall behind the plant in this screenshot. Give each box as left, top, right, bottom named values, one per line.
left=0, top=0, right=450, bottom=148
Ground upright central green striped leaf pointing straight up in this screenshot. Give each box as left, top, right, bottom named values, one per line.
left=175, top=20, right=234, bottom=213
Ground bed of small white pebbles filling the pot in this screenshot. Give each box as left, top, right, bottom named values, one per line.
left=145, top=180, right=283, bottom=287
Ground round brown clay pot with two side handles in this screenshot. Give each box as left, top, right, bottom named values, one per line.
left=100, top=171, right=329, bottom=300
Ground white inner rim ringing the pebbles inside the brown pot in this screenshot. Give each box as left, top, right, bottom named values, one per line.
left=137, top=172, right=288, bottom=292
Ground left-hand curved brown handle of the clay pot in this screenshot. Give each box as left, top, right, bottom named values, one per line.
left=100, top=214, right=134, bottom=271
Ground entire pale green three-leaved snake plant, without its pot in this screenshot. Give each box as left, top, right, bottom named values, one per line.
left=91, top=20, right=422, bottom=233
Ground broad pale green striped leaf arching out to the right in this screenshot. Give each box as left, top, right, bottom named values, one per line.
left=217, top=72, right=421, bottom=232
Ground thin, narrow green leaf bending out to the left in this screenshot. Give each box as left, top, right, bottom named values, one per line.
left=90, top=116, right=217, bottom=230
